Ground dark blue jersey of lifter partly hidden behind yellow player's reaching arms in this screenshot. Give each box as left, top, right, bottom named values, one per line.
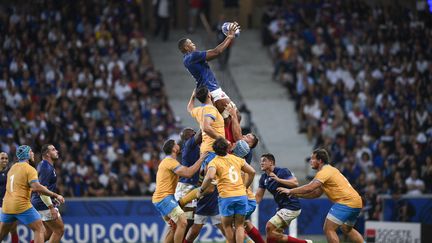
left=179, top=136, right=200, bottom=185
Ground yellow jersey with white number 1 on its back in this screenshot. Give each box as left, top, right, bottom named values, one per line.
left=2, top=162, right=38, bottom=214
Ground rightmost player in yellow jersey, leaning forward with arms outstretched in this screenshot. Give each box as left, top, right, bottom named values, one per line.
left=278, top=149, right=364, bottom=243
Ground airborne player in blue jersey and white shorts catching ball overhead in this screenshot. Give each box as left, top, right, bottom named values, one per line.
left=178, top=22, right=240, bottom=142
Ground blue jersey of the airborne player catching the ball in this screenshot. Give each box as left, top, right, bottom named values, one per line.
left=183, top=51, right=219, bottom=92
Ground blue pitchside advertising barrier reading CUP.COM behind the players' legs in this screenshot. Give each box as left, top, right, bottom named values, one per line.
left=7, top=195, right=432, bottom=243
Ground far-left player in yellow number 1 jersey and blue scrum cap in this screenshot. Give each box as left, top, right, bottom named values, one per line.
left=0, top=145, right=64, bottom=243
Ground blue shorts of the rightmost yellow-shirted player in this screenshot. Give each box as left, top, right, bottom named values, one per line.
left=327, top=203, right=361, bottom=226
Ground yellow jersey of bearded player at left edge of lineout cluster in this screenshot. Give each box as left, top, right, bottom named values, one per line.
left=152, top=156, right=181, bottom=203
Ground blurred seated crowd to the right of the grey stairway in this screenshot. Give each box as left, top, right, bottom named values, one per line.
left=262, top=1, right=432, bottom=219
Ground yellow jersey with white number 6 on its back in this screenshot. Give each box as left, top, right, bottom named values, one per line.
left=207, top=154, right=246, bottom=198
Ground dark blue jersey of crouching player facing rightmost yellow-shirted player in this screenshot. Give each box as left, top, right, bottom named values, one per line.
left=259, top=167, right=301, bottom=210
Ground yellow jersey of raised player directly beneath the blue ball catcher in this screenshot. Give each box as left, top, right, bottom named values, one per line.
left=191, top=105, right=225, bottom=154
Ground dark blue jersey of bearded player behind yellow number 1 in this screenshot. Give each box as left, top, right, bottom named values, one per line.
left=31, top=160, right=57, bottom=211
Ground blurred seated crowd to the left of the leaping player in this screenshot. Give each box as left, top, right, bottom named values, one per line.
left=0, top=0, right=177, bottom=197
